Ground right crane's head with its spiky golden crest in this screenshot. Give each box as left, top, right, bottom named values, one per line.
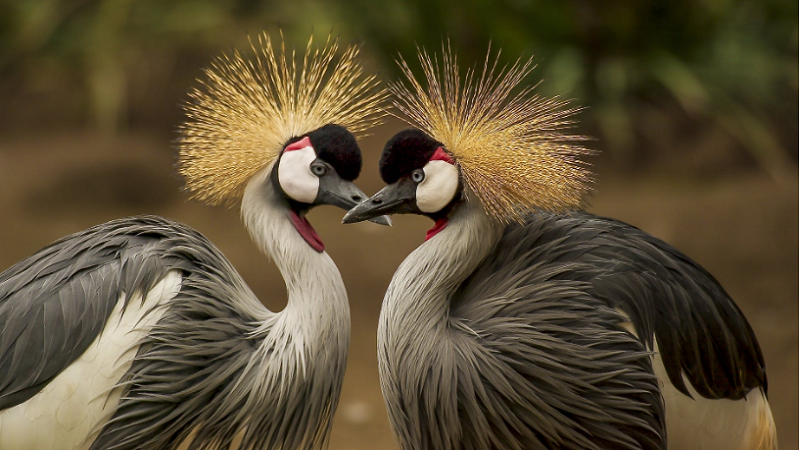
left=349, top=42, right=592, bottom=229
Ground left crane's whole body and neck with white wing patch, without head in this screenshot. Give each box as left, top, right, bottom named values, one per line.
left=0, top=161, right=350, bottom=450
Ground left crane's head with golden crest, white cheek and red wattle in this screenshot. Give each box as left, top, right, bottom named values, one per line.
left=178, top=33, right=389, bottom=252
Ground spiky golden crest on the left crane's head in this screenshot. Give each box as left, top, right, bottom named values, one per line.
left=178, top=33, right=386, bottom=205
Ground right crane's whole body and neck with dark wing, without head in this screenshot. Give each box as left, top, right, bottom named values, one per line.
left=366, top=198, right=774, bottom=449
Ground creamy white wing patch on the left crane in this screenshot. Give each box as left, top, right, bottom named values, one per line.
left=0, top=271, right=181, bottom=450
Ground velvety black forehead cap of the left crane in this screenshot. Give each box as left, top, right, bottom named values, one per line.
left=308, top=124, right=362, bottom=181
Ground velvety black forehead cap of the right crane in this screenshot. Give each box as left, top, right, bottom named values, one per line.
left=380, top=129, right=442, bottom=184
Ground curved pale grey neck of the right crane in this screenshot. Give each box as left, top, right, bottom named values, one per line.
left=378, top=199, right=503, bottom=450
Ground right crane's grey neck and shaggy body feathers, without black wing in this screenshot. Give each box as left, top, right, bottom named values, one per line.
left=378, top=203, right=666, bottom=450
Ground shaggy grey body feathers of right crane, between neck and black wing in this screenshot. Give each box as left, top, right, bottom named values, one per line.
left=451, top=227, right=666, bottom=450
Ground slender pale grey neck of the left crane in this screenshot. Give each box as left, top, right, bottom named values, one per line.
left=228, top=165, right=350, bottom=449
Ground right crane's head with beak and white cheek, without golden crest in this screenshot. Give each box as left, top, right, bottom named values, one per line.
left=343, top=129, right=463, bottom=238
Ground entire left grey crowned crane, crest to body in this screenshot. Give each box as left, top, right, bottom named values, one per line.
left=0, top=35, right=384, bottom=450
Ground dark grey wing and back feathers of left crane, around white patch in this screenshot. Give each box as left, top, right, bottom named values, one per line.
left=0, top=216, right=277, bottom=450
